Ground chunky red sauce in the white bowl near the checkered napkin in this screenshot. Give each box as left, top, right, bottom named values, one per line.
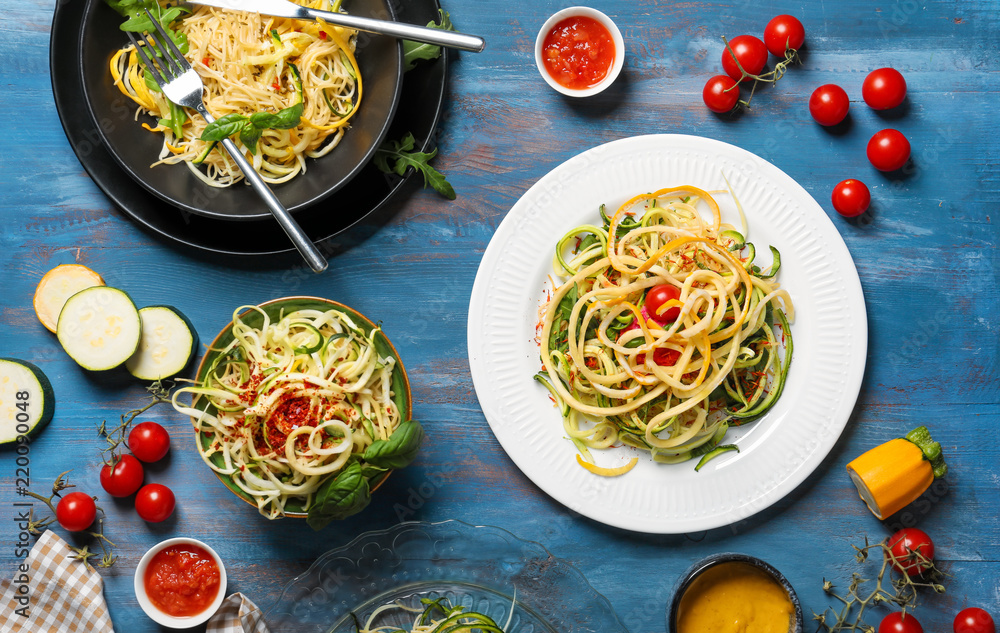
left=143, top=545, right=221, bottom=618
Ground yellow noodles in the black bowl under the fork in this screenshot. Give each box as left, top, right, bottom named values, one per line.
left=110, top=0, right=362, bottom=187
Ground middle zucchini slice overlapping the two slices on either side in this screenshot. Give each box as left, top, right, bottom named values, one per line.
left=56, top=286, right=142, bottom=371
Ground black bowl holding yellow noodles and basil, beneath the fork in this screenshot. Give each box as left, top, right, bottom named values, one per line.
left=80, top=0, right=403, bottom=220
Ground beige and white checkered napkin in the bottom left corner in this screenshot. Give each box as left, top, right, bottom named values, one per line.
left=0, top=530, right=113, bottom=633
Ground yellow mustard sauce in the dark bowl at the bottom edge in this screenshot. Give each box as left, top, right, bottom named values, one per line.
left=677, top=562, right=795, bottom=633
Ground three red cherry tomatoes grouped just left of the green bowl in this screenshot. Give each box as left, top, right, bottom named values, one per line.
left=101, top=422, right=175, bottom=523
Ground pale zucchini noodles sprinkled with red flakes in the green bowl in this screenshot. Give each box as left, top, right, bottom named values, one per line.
left=173, top=306, right=400, bottom=519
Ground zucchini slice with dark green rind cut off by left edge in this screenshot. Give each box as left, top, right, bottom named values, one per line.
left=0, top=358, right=56, bottom=444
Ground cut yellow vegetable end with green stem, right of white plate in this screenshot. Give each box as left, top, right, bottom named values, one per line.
left=847, top=426, right=948, bottom=519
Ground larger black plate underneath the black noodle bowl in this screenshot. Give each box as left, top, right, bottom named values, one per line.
left=49, top=0, right=448, bottom=255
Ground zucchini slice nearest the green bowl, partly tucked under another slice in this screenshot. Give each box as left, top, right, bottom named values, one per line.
left=125, top=306, right=198, bottom=381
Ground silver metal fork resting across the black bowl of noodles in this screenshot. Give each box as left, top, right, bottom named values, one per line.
left=128, top=9, right=327, bottom=273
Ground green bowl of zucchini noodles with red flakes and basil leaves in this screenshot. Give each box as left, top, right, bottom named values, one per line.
left=173, top=297, right=423, bottom=529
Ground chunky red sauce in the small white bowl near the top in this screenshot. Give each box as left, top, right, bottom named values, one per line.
left=542, top=16, right=615, bottom=90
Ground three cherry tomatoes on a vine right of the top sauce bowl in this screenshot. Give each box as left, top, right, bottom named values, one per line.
left=701, top=15, right=806, bottom=114
